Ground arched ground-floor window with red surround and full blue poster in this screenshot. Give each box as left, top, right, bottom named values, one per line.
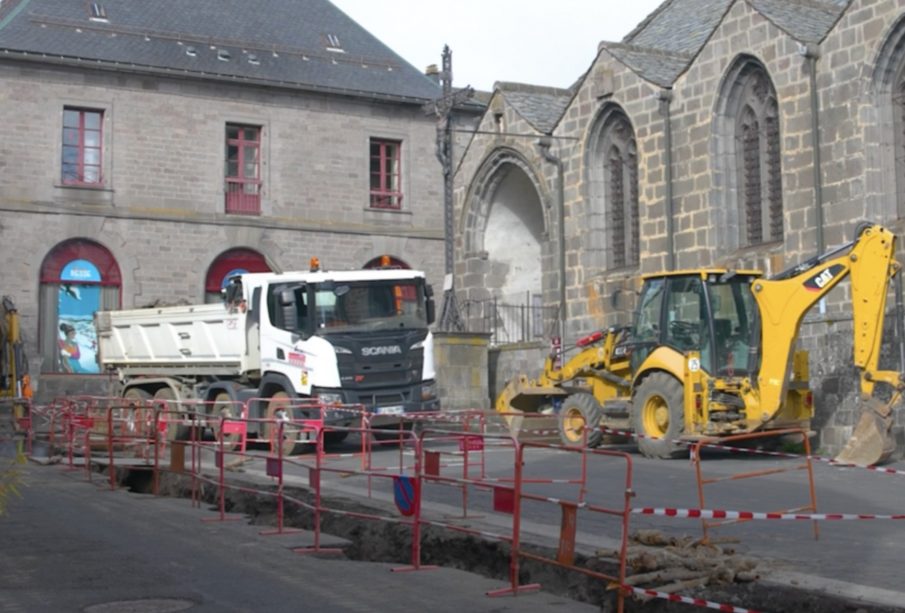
left=38, top=239, right=122, bottom=374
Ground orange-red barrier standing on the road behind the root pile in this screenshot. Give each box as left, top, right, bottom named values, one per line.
left=691, top=428, right=819, bottom=543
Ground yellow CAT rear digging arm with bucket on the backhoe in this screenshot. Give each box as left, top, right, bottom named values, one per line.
left=749, top=224, right=903, bottom=465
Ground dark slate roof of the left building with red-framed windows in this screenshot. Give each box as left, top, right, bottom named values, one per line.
left=0, top=0, right=441, bottom=104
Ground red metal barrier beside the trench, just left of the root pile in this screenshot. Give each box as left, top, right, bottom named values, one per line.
left=488, top=443, right=635, bottom=613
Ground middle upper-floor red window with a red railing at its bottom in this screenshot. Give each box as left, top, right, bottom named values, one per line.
left=224, top=124, right=261, bottom=215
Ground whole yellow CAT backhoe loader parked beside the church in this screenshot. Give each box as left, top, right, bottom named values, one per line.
left=496, top=223, right=905, bottom=466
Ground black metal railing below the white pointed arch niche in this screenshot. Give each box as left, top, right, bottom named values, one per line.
left=460, top=296, right=557, bottom=345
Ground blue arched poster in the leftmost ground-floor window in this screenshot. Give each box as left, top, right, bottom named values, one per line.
left=57, top=260, right=101, bottom=374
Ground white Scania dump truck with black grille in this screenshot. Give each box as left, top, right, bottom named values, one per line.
left=95, top=261, right=439, bottom=439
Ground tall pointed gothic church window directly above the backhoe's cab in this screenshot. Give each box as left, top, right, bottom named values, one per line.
left=734, top=64, right=783, bottom=245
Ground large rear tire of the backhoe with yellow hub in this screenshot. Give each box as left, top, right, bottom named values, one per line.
left=631, top=372, right=688, bottom=459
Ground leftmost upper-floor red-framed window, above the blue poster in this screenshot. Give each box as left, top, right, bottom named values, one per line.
left=60, top=106, right=104, bottom=186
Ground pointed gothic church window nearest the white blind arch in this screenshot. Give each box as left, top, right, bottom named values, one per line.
left=586, top=107, right=641, bottom=269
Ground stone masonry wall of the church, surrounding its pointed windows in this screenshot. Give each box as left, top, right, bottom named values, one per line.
left=456, top=0, right=905, bottom=449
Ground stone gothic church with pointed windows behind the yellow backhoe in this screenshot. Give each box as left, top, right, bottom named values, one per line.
left=456, top=0, right=905, bottom=451
